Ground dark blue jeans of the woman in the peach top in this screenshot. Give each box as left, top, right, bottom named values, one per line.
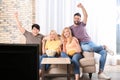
left=61, top=52, right=83, bottom=74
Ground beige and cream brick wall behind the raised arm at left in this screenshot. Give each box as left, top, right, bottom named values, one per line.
left=0, top=0, right=35, bottom=43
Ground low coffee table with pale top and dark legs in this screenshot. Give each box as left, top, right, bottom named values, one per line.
left=41, top=58, right=71, bottom=80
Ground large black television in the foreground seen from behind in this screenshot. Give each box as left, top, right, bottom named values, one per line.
left=0, top=44, right=39, bottom=80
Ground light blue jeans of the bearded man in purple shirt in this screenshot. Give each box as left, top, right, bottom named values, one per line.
left=80, top=41, right=107, bottom=70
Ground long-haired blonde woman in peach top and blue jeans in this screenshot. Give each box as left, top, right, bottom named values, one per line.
left=61, top=27, right=82, bottom=80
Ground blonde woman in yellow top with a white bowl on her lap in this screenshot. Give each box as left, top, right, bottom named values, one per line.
left=39, top=30, right=61, bottom=76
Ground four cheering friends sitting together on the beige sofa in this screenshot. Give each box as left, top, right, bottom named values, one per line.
left=14, top=3, right=114, bottom=80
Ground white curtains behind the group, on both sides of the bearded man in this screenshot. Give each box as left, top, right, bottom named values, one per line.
left=36, top=0, right=116, bottom=52
